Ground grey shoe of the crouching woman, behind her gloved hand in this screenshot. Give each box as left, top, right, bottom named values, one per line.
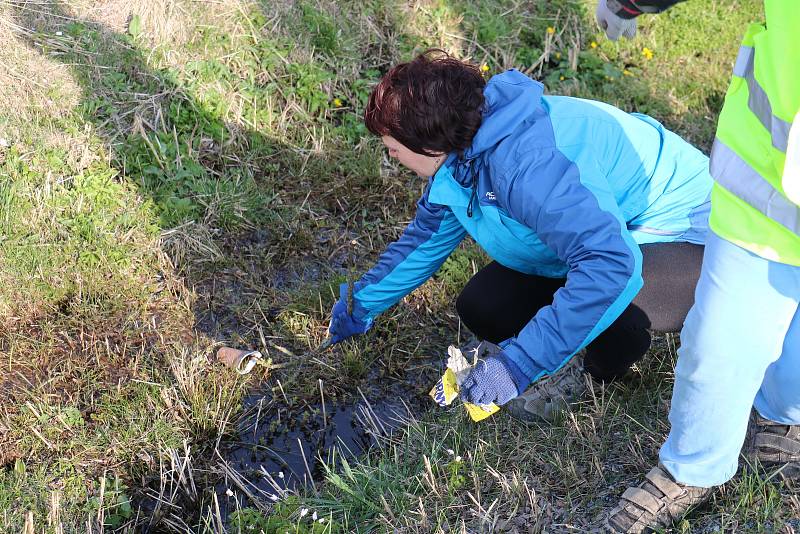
left=503, top=355, right=591, bottom=422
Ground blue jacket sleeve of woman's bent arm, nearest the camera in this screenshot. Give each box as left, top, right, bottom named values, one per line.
left=496, top=149, right=643, bottom=382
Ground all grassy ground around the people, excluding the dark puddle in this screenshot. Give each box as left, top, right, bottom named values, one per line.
left=0, top=0, right=800, bottom=533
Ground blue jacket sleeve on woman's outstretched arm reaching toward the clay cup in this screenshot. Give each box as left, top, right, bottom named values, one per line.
left=353, top=181, right=466, bottom=320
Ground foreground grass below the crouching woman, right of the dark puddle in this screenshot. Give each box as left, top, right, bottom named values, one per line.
left=294, top=338, right=798, bottom=532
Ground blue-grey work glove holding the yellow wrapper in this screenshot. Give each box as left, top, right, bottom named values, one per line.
left=460, top=352, right=530, bottom=406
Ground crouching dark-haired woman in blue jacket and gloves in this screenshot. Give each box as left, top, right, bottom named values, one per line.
left=329, top=51, right=712, bottom=426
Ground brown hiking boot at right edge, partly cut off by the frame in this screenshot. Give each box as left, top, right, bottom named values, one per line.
left=745, top=410, right=800, bottom=481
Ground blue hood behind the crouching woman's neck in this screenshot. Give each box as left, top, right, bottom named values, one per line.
left=464, top=69, right=544, bottom=159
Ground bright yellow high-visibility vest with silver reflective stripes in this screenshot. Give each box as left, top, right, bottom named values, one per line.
left=709, top=0, right=800, bottom=265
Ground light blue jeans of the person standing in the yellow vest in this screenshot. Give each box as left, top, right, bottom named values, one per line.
left=659, top=233, right=800, bottom=487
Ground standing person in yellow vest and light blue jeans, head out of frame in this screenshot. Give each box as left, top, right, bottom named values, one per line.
left=597, top=0, right=800, bottom=533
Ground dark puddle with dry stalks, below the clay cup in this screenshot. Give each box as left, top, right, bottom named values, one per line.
left=216, top=380, right=433, bottom=517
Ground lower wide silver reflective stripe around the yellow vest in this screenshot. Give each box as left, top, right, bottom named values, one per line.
left=709, top=138, right=800, bottom=236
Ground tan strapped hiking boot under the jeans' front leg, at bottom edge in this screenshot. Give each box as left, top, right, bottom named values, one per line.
left=605, top=465, right=713, bottom=534
